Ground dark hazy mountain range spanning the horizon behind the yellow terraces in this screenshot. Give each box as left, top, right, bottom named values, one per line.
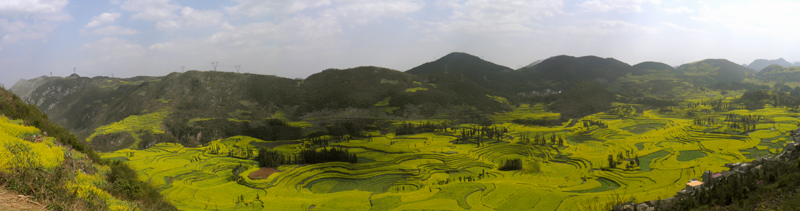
left=11, top=53, right=788, bottom=150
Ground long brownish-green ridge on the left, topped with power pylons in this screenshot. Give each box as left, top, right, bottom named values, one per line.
left=11, top=67, right=507, bottom=150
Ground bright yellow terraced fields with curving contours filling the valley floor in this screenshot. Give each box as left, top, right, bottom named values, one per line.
left=103, top=97, right=800, bottom=210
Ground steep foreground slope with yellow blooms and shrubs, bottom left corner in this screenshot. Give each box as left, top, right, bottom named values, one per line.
left=0, top=86, right=174, bottom=210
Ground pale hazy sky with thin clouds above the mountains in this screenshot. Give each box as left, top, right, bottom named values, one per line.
left=0, top=0, right=800, bottom=88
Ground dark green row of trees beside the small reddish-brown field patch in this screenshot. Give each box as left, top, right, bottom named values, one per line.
left=255, top=148, right=358, bottom=168
